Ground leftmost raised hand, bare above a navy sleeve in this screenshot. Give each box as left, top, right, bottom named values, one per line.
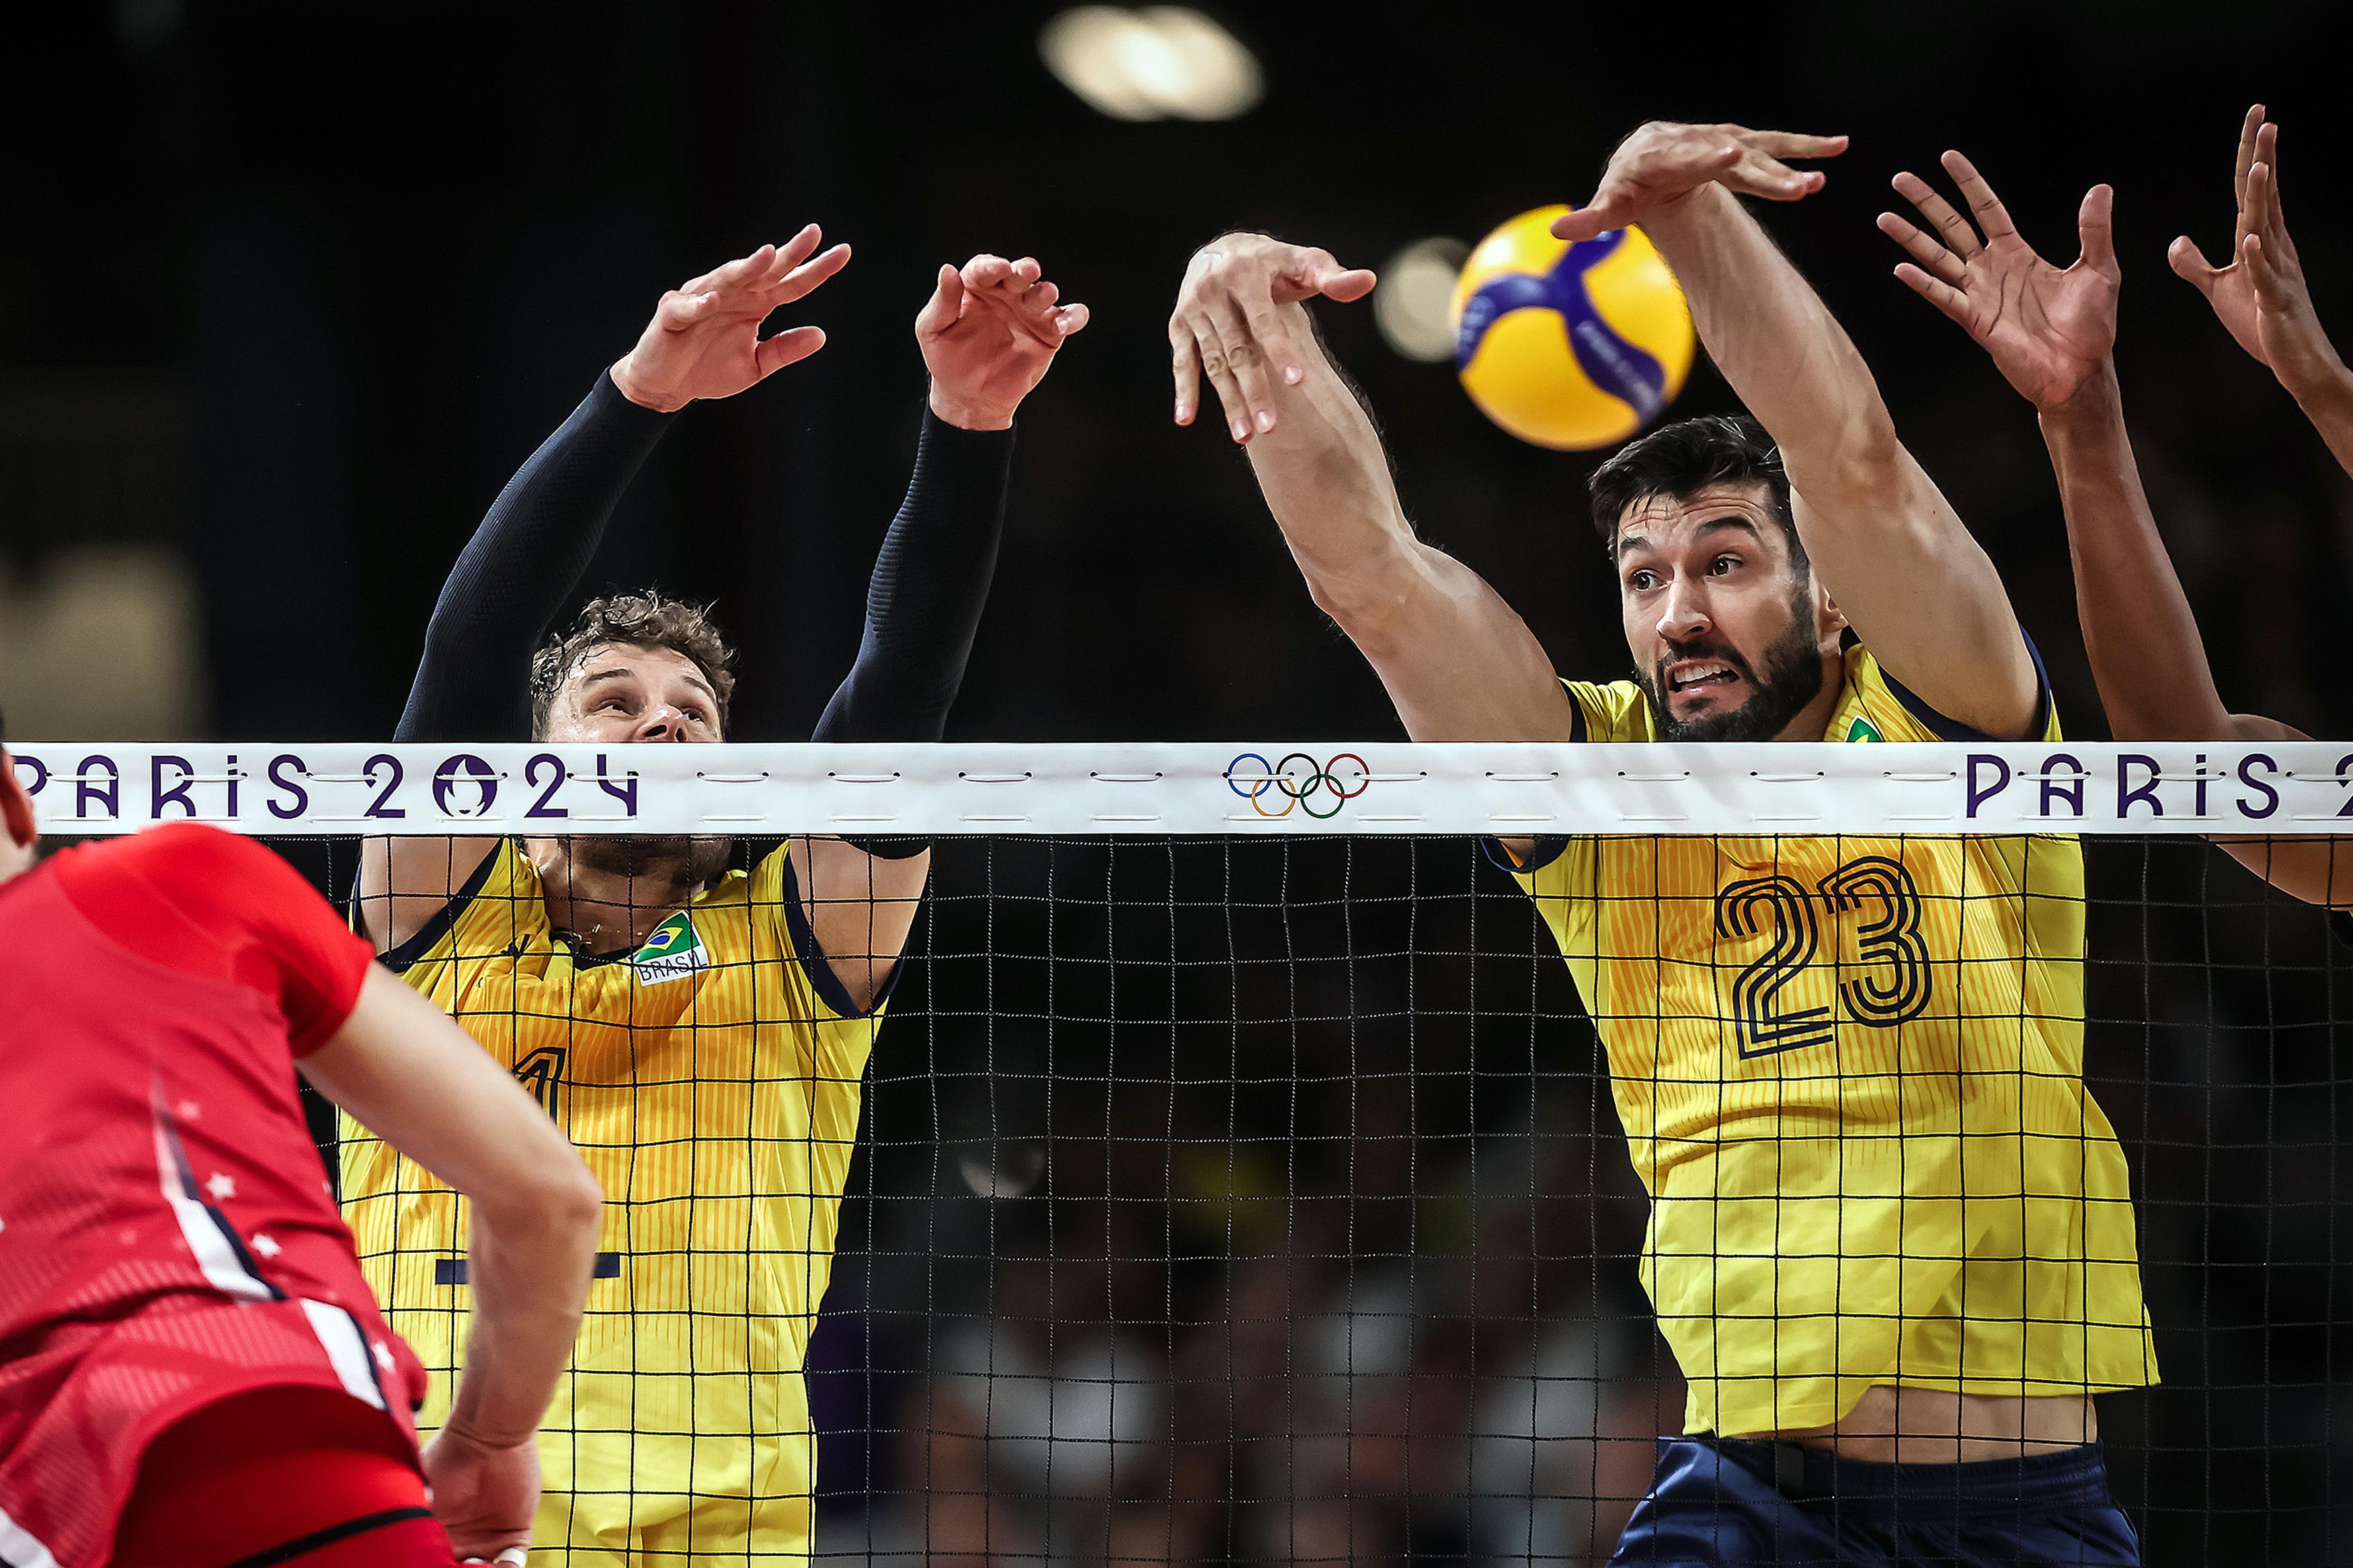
left=612, top=223, right=850, bottom=414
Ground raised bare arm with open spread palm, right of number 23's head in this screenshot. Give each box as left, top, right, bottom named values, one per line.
left=1880, top=153, right=2353, bottom=903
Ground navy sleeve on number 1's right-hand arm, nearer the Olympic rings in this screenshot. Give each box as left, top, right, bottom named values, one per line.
left=814, top=409, right=1014, bottom=741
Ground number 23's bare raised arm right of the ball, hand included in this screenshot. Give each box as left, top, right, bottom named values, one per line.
left=1553, top=124, right=2040, bottom=738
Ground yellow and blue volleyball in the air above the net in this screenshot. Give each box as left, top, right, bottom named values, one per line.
left=1452, top=207, right=1697, bottom=452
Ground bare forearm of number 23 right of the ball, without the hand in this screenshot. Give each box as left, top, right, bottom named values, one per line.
left=1642, top=183, right=1901, bottom=505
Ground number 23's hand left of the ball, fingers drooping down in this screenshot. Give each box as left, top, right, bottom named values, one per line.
left=1170, top=235, right=1377, bottom=442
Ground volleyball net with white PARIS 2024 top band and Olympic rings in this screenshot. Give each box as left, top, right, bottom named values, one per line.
left=17, top=743, right=2353, bottom=1563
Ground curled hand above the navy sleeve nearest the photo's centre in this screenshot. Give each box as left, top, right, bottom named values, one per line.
left=916, top=256, right=1087, bottom=430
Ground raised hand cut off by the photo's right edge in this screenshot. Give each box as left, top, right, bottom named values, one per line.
left=2165, top=104, right=2344, bottom=395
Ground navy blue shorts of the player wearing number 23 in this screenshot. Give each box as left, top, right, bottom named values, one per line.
left=1609, top=1436, right=2141, bottom=1568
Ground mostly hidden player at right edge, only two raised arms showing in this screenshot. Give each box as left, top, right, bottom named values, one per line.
left=1880, top=104, right=2353, bottom=907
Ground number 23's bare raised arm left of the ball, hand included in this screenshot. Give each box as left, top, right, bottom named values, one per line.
left=1170, top=235, right=1574, bottom=741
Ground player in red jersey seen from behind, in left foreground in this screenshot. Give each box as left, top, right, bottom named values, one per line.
left=0, top=714, right=598, bottom=1568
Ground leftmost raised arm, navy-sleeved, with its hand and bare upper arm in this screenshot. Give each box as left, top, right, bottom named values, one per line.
left=358, top=223, right=850, bottom=952
